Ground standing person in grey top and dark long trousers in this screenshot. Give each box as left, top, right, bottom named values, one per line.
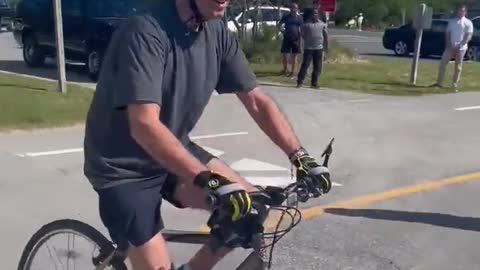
left=297, top=8, right=328, bottom=88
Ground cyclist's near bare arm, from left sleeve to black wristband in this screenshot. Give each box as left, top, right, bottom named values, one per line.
left=128, top=104, right=207, bottom=182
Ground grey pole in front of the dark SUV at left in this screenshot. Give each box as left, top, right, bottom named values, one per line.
left=52, top=0, right=67, bottom=94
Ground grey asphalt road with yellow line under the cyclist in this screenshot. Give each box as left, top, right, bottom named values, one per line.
left=0, top=83, right=480, bottom=270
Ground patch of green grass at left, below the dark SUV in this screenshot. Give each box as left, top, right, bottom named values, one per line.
left=0, top=74, right=93, bottom=130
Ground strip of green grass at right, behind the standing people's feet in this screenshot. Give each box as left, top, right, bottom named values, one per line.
left=252, top=58, right=480, bottom=95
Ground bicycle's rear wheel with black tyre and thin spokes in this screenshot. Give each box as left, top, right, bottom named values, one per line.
left=18, top=219, right=127, bottom=270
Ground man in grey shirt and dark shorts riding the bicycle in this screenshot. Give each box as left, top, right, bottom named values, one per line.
left=84, top=0, right=331, bottom=270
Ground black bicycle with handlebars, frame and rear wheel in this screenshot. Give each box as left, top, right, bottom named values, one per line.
left=18, top=138, right=334, bottom=270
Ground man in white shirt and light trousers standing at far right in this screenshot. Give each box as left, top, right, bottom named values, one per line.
left=434, top=5, right=473, bottom=92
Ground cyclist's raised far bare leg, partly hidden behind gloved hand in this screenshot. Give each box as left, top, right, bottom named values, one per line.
left=174, top=158, right=257, bottom=270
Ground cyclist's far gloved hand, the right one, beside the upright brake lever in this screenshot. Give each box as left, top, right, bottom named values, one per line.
left=290, top=148, right=332, bottom=197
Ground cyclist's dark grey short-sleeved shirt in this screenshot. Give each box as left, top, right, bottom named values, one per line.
left=84, top=0, right=257, bottom=189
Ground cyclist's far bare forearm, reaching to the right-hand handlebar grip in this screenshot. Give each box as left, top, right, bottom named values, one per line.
left=237, top=88, right=301, bottom=155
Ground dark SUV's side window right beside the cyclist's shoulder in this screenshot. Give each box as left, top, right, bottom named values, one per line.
left=87, top=0, right=142, bottom=17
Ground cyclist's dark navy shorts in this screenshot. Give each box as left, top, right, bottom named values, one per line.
left=96, top=142, right=215, bottom=250
